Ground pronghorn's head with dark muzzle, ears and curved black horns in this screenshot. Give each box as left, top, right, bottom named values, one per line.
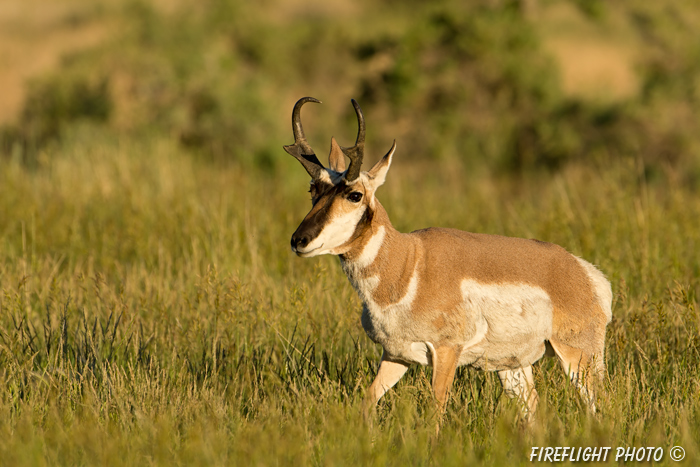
left=284, top=97, right=396, bottom=258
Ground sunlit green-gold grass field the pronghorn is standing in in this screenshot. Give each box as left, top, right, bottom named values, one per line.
left=0, top=131, right=700, bottom=465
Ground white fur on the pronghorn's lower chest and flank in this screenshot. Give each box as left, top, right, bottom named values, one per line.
left=362, top=277, right=552, bottom=370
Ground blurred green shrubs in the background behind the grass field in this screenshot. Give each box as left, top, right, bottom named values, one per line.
left=2, top=0, right=700, bottom=185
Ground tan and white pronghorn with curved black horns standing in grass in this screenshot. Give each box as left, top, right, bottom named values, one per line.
left=284, top=97, right=612, bottom=420
